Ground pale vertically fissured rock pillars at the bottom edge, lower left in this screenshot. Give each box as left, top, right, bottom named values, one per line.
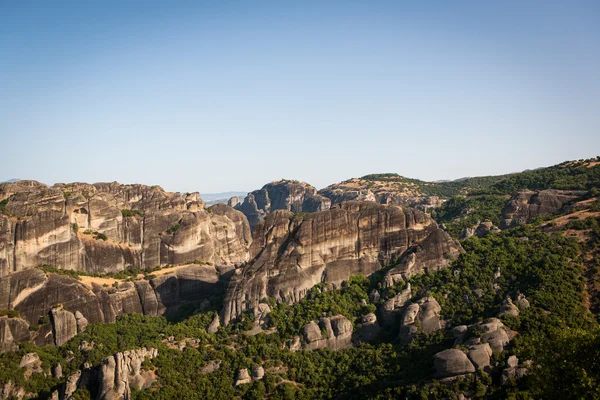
left=98, top=348, right=158, bottom=400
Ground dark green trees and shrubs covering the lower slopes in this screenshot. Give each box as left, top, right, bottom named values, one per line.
left=0, top=220, right=600, bottom=399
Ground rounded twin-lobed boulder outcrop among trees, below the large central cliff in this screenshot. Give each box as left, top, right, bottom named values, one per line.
left=302, top=315, right=353, bottom=350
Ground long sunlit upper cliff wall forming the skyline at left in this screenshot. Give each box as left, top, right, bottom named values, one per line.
left=0, top=181, right=252, bottom=276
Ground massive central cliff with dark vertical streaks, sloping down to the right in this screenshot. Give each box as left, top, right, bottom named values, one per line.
left=223, top=202, right=459, bottom=323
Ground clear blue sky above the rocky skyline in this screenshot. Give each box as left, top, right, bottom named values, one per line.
left=0, top=0, right=600, bottom=192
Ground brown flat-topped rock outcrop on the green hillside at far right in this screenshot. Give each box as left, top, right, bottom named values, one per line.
left=500, top=190, right=583, bottom=229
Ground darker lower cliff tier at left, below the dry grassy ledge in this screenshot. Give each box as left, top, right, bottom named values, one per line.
left=0, top=265, right=232, bottom=352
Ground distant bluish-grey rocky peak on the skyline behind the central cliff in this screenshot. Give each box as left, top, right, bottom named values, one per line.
left=232, top=180, right=331, bottom=227
